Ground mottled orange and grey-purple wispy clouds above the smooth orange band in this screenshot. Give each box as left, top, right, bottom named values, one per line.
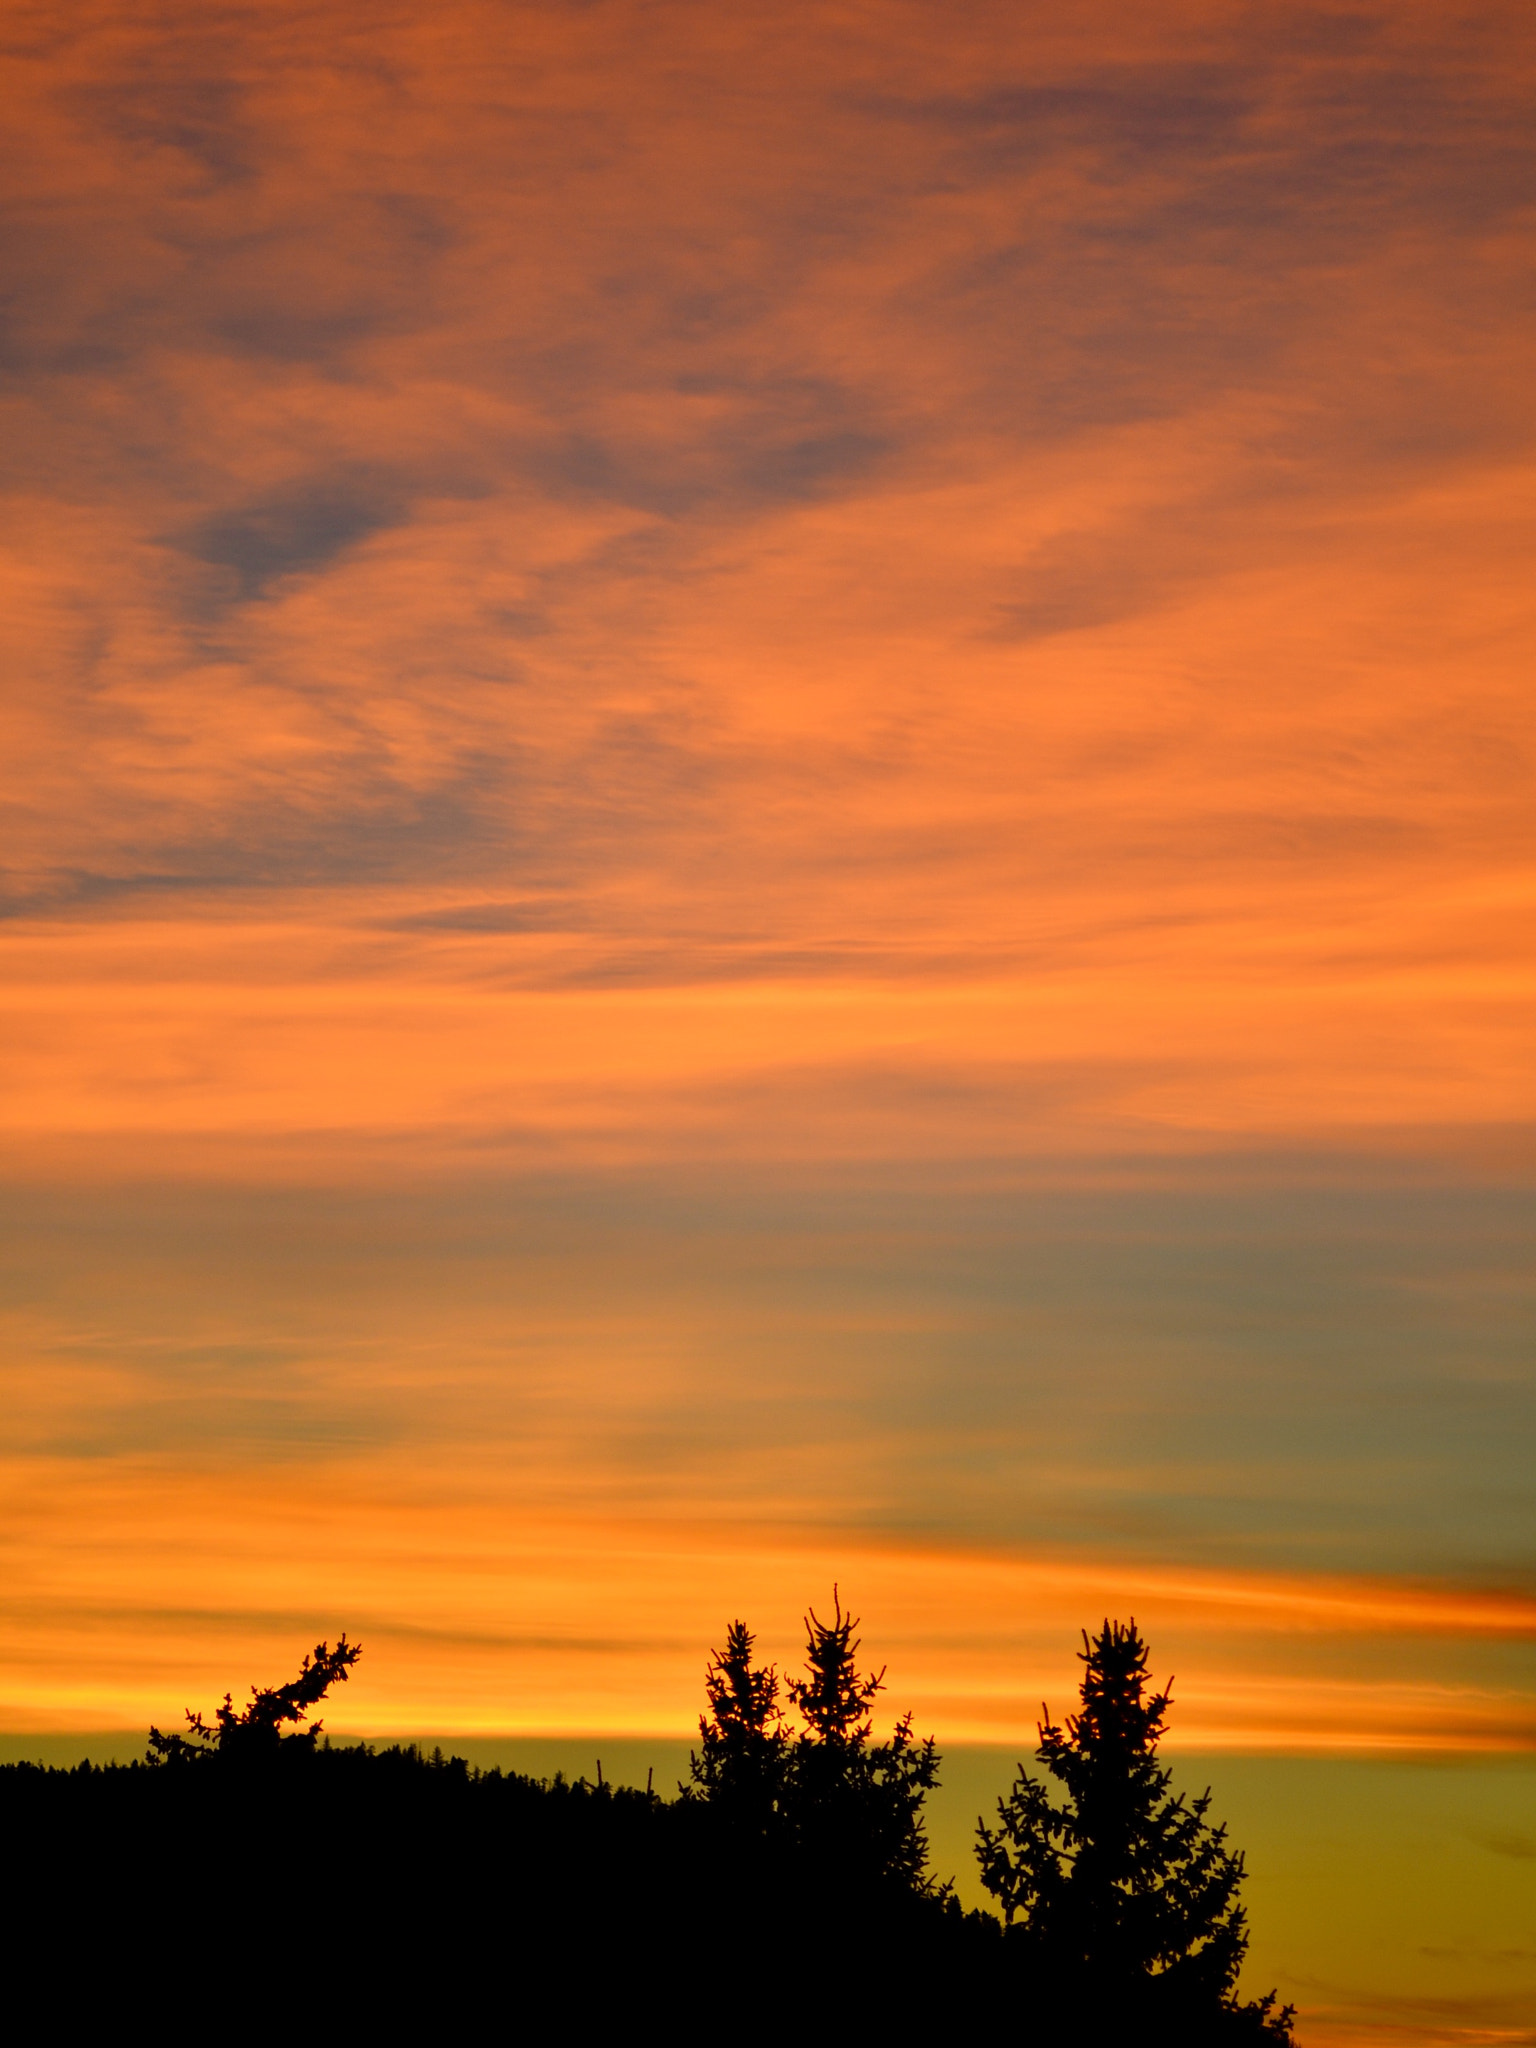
left=8, top=6, right=1532, bottom=966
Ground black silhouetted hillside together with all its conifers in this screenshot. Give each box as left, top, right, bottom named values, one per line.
left=0, top=1591, right=1292, bottom=2048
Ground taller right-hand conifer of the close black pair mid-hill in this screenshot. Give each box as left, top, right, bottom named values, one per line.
left=786, top=1585, right=948, bottom=1896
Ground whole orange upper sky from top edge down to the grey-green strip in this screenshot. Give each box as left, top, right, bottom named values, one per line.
left=0, top=6, right=1532, bottom=1187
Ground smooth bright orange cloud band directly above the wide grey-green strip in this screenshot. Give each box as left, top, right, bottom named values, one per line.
left=0, top=905, right=1536, bottom=1157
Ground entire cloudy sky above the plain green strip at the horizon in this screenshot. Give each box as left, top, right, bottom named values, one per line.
left=0, top=0, right=1536, bottom=2040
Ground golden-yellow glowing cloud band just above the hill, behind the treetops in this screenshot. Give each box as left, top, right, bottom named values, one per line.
left=2, top=1464, right=1536, bottom=1749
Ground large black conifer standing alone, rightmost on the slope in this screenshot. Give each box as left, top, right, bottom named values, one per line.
left=977, top=1620, right=1290, bottom=2040
